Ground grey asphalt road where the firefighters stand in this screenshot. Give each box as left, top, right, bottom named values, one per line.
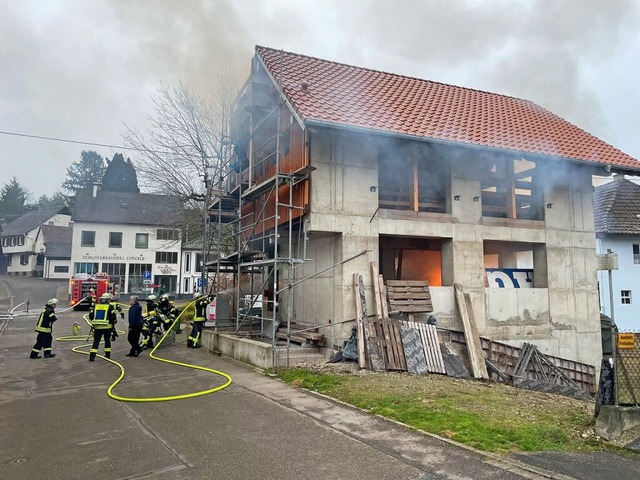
left=0, top=277, right=640, bottom=480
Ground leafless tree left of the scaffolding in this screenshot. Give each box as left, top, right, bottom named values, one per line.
left=123, top=73, right=236, bottom=290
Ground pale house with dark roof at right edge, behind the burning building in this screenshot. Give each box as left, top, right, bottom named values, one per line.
left=593, top=175, right=640, bottom=331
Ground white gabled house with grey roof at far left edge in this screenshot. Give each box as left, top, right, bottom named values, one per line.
left=0, top=206, right=71, bottom=276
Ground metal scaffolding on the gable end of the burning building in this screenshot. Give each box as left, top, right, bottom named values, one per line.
left=208, top=49, right=313, bottom=365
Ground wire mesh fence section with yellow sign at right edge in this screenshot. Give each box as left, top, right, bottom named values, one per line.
left=615, top=333, right=640, bottom=405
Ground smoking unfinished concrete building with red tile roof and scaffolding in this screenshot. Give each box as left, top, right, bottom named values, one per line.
left=205, top=47, right=640, bottom=374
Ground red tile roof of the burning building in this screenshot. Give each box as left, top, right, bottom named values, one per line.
left=256, top=46, right=640, bottom=170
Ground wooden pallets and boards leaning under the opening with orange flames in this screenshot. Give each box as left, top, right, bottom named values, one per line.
left=353, top=262, right=446, bottom=373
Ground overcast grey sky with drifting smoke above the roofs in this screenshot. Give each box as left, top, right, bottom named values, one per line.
left=0, top=0, right=640, bottom=200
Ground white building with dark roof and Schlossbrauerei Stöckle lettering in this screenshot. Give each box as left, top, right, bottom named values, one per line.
left=71, top=185, right=182, bottom=294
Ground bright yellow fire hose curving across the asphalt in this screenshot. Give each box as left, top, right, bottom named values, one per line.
left=56, top=301, right=233, bottom=403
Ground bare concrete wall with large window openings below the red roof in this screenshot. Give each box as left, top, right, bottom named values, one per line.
left=293, top=126, right=601, bottom=366
